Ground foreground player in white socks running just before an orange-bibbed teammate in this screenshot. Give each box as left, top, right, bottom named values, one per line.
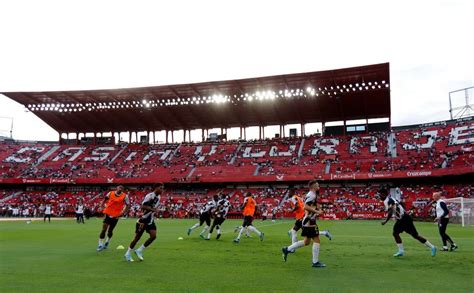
left=281, top=180, right=326, bottom=268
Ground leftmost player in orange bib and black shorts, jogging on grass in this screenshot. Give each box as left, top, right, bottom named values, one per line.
left=97, top=185, right=130, bottom=251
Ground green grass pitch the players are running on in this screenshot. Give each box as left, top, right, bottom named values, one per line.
left=0, top=219, right=474, bottom=292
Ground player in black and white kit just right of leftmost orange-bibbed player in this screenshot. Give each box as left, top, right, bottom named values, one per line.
left=125, top=183, right=164, bottom=262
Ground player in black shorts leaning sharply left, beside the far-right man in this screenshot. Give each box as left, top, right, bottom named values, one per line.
left=379, top=188, right=437, bottom=257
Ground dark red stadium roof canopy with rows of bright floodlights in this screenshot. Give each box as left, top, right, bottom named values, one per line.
left=3, top=63, right=390, bottom=133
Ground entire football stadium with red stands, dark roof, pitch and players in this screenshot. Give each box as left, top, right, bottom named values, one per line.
left=0, top=1, right=474, bottom=292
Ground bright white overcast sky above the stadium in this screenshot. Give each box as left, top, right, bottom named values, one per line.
left=0, top=0, right=474, bottom=140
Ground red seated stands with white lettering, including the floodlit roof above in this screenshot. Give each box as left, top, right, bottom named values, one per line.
left=0, top=63, right=474, bottom=219
